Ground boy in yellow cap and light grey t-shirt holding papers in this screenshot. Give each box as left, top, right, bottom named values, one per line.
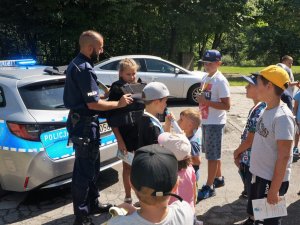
left=245, top=65, right=296, bottom=225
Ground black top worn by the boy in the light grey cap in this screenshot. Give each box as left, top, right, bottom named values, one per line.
left=138, top=114, right=161, bottom=148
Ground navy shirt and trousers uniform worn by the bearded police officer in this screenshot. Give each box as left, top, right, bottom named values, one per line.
left=64, top=53, right=100, bottom=218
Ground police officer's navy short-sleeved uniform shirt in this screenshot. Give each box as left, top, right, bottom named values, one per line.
left=64, top=53, right=99, bottom=115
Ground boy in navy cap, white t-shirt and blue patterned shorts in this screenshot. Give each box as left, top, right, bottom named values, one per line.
left=198, top=50, right=230, bottom=200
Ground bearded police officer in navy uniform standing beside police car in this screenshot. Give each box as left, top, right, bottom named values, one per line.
left=64, top=31, right=133, bottom=225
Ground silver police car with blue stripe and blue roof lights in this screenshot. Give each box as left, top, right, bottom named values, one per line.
left=0, top=59, right=120, bottom=192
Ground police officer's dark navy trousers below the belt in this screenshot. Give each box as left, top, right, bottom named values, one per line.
left=72, top=140, right=100, bottom=217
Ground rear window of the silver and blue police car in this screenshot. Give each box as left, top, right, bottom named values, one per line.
left=19, top=82, right=66, bottom=110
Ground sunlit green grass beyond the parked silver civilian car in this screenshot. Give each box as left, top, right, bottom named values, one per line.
left=209, top=66, right=300, bottom=86
